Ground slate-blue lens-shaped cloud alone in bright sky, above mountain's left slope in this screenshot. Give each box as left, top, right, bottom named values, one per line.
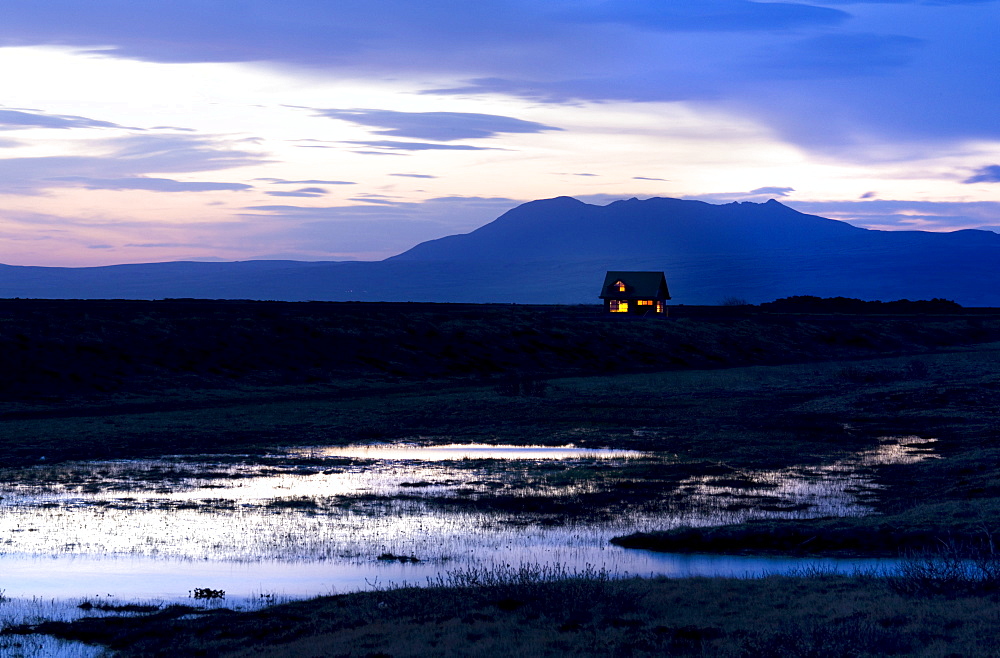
left=316, top=109, right=561, bottom=142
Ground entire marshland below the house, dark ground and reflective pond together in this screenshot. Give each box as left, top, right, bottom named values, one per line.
left=0, top=300, right=1000, bottom=655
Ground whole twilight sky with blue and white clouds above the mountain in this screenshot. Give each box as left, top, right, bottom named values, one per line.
left=0, top=0, right=1000, bottom=266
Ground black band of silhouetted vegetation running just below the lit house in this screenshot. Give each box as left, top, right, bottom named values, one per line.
left=0, top=298, right=1000, bottom=402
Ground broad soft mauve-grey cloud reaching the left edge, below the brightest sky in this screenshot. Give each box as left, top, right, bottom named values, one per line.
left=0, top=135, right=268, bottom=194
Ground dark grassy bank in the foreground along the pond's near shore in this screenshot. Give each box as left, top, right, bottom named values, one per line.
left=13, top=568, right=1000, bottom=657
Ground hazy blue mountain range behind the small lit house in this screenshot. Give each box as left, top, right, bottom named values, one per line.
left=0, top=197, right=1000, bottom=306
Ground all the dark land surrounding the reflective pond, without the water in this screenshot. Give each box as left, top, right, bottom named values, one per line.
left=0, top=300, right=1000, bottom=656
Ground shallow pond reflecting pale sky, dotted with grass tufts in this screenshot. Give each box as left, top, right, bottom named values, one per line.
left=0, top=437, right=936, bottom=624
